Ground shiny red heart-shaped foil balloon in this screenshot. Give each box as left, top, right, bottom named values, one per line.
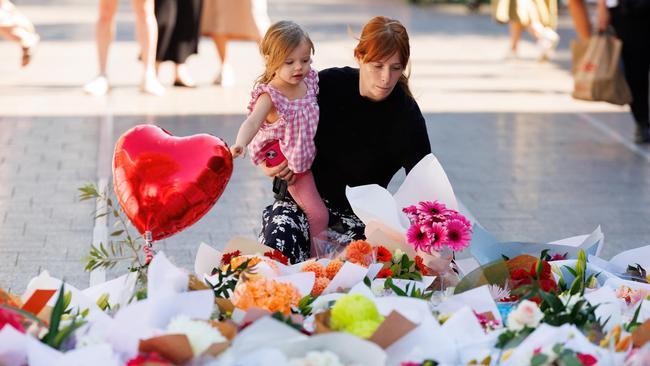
left=113, top=125, right=232, bottom=240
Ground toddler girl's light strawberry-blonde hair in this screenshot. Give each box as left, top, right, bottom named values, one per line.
left=255, top=20, right=315, bottom=84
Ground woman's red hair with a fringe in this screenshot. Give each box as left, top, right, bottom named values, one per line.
left=354, top=16, right=411, bottom=96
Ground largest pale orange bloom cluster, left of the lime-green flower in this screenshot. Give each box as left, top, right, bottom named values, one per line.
left=231, top=277, right=300, bottom=315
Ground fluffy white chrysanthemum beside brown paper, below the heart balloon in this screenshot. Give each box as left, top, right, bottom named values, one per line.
left=167, top=315, right=226, bottom=356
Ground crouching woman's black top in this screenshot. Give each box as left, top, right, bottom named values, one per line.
left=312, top=67, right=431, bottom=209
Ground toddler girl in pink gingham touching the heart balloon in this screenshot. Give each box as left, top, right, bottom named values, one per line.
left=230, top=21, right=329, bottom=255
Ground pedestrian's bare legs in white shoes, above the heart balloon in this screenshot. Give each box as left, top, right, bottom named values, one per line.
left=84, top=0, right=165, bottom=95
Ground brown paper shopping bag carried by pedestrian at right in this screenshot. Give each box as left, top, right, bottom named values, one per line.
left=572, top=34, right=632, bottom=105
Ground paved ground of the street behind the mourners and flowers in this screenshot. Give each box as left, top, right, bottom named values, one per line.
left=0, top=0, right=650, bottom=291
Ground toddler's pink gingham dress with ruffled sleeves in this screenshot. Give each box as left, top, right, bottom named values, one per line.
left=248, top=69, right=318, bottom=173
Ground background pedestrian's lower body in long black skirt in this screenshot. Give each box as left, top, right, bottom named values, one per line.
left=156, top=0, right=202, bottom=87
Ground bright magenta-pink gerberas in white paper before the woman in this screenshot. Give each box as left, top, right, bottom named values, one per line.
left=402, top=201, right=472, bottom=254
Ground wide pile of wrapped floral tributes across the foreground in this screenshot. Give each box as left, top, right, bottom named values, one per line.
left=0, top=177, right=650, bottom=366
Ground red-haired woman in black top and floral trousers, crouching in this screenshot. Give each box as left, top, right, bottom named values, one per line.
left=259, top=17, right=431, bottom=263
